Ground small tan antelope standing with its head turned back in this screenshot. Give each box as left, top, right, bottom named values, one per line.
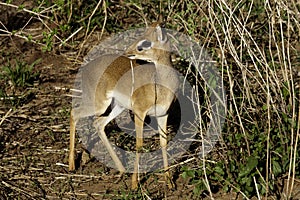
left=69, top=23, right=179, bottom=189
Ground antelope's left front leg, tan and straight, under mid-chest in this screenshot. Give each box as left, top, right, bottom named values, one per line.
left=131, top=114, right=146, bottom=190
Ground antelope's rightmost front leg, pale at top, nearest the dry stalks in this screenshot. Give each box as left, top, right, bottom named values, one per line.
left=157, top=115, right=175, bottom=189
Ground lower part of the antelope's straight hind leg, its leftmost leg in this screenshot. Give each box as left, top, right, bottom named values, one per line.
left=69, top=110, right=76, bottom=171
